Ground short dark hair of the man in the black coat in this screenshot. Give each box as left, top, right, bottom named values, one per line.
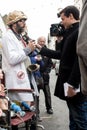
left=57, top=6, right=79, bottom=20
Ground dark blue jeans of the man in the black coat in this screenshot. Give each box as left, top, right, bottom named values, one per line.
left=67, top=101, right=87, bottom=130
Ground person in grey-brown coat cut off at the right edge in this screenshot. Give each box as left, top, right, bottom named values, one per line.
left=77, top=0, right=87, bottom=95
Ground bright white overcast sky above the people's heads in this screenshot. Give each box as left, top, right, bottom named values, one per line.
left=0, top=0, right=73, bottom=39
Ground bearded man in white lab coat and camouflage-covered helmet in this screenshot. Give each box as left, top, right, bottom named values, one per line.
left=2, top=10, right=36, bottom=104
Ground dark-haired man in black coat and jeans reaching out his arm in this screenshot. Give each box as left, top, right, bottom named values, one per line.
left=38, top=6, right=87, bottom=130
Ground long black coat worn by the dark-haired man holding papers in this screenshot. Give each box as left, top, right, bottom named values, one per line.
left=41, top=23, right=87, bottom=100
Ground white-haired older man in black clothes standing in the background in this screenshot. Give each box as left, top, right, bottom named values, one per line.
left=37, top=36, right=53, bottom=114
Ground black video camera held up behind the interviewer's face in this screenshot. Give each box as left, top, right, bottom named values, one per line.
left=50, top=23, right=65, bottom=36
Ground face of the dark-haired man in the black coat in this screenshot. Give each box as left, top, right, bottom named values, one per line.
left=60, top=13, right=71, bottom=28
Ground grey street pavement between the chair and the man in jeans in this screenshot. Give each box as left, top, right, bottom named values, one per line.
left=38, top=69, right=69, bottom=130
